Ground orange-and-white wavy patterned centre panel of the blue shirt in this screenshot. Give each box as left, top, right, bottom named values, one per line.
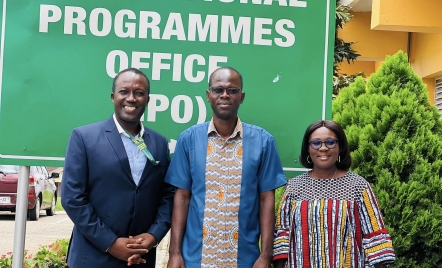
left=201, top=118, right=242, bottom=268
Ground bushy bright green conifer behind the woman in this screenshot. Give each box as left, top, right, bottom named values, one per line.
left=333, top=51, right=442, bottom=268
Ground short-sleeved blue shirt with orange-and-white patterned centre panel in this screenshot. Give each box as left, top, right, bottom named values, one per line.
left=165, top=118, right=286, bottom=268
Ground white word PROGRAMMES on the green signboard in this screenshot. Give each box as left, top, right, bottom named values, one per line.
left=39, top=4, right=296, bottom=47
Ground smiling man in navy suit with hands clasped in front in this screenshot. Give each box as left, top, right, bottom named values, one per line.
left=62, top=68, right=175, bottom=268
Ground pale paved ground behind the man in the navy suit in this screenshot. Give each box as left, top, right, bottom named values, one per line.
left=0, top=211, right=169, bottom=268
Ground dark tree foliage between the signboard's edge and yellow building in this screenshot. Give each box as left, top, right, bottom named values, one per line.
left=333, top=1, right=364, bottom=95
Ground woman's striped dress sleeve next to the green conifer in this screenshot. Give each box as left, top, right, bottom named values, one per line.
left=358, top=183, right=396, bottom=267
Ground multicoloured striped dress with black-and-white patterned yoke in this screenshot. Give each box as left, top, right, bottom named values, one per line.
left=273, top=172, right=395, bottom=268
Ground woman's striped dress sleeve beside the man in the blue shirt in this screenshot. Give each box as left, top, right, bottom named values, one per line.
left=273, top=184, right=292, bottom=260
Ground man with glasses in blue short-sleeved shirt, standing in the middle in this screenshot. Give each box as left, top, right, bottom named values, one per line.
left=166, top=67, right=286, bottom=268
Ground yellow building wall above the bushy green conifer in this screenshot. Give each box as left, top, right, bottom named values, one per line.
left=338, top=3, right=442, bottom=104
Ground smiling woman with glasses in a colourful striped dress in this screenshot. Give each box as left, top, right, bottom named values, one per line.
left=273, top=120, right=395, bottom=268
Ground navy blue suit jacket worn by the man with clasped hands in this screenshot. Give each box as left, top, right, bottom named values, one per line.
left=61, top=117, right=174, bottom=268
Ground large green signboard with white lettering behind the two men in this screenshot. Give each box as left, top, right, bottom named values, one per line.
left=0, top=0, right=335, bottom=174
